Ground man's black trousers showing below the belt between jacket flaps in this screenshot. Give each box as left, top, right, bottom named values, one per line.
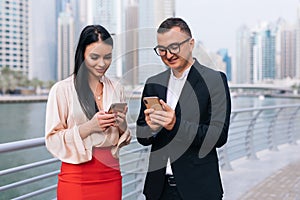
left=159, top=175, right=182, bottom=200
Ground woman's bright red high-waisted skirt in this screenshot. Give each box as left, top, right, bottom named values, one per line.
left=57, top=148, right=122, bottom=200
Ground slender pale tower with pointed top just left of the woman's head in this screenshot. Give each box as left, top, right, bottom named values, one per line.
left=57, top=3, right=75, bottom=80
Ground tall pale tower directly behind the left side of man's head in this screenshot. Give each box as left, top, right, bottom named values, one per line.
left=138, top=0, right=175, bottom=84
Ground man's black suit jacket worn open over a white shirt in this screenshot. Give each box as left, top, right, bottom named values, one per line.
left=136, top=60, right=231, bottom=200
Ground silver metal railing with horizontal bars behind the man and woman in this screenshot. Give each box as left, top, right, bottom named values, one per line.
left=0, top=104, right=300, bottom=200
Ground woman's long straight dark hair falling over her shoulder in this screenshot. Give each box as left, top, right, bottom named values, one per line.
left=73, top=25, right=113, bottom=119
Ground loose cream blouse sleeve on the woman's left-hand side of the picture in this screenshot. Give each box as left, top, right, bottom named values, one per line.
left=45, top=80, right=92, bottom=164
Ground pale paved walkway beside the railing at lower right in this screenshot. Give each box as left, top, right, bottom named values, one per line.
left=221, top=142, right=300, bottom=200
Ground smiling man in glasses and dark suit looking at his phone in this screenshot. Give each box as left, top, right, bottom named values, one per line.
left=136, top=18, right=231, bottom=200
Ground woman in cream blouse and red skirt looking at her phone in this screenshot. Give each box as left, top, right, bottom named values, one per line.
left=45, top=25, right=131, bottom=200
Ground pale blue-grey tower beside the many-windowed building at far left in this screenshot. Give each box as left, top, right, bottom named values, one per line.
left=29, top=0, right=60, bottom=81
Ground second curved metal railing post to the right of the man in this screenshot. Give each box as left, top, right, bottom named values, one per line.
left=245, top=110, right=262, bottom=160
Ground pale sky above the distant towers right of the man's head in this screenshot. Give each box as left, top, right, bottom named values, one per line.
left=176, top=0, right=299, bottom=55
